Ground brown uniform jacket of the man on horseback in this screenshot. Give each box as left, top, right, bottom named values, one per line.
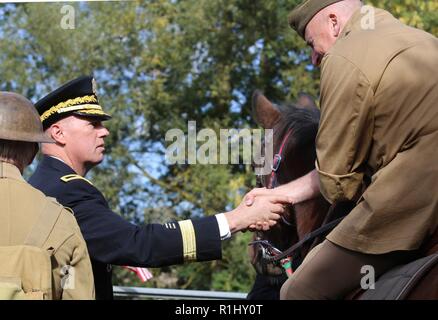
left=317, top=9, right=438, bottom=254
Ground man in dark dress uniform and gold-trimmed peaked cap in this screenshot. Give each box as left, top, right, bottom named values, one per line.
left=30, top=76, right=287, bottom=299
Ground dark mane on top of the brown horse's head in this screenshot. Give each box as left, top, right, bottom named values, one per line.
left=276, top=105, right=320, bottom=148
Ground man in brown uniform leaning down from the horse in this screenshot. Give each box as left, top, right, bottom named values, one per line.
left=248, top=0, right=438, bottom=299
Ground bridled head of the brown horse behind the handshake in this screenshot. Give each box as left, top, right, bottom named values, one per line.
left=250, top=91, right=330, bottom=277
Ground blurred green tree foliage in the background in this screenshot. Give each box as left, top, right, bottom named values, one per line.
left=0, top=0, right=438, bottom=291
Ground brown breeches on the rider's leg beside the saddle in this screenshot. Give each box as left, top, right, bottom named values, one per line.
left=280, top=240, right=413, bottom=300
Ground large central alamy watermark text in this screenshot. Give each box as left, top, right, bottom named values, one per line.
left=165, top=121, right=274, bottom=175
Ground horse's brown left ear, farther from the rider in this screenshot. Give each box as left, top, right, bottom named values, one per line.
left=252, top=90, right=281, bottom=129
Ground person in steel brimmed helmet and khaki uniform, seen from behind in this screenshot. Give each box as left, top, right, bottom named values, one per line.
left=0, top=92, right=94, bottom=299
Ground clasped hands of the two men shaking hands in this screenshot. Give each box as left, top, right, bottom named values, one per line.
left=224, top=188, right=292, bottom=233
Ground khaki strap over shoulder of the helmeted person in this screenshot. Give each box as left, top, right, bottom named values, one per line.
left=24, top=197, right=64, bottom=248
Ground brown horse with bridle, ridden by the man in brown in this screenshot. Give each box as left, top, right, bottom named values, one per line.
left=248, top=92, right=438, bottom=299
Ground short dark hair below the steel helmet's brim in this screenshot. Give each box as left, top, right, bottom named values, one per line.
left=0, top=139, right=38, bottom=168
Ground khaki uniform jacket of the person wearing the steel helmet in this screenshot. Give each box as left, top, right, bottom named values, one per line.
left=0, top=162, right=94, bottom=299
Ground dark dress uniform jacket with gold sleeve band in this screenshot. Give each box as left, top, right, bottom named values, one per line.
left=29, top=157, right=221, bottom=299
